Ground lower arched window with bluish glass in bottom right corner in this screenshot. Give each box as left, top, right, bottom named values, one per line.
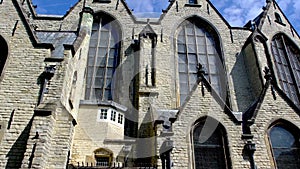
left=268, top=124, right=300, bottom=169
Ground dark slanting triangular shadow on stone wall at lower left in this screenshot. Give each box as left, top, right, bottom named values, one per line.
left=5, top=117, right=33, bottom=169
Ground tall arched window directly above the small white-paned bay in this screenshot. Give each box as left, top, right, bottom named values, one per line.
left=85, top=13, right=121, bottom=100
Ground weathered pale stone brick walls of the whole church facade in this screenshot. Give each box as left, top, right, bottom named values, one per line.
left=0, top=0, right=300, bottom=169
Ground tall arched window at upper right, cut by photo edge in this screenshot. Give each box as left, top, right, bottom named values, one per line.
left=271, top=34, right=300, bottom=107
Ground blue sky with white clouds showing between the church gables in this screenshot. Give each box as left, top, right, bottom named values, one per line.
left=32, top=0, right=300, bottom=34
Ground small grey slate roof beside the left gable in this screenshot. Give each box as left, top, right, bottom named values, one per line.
left=35, top=31, right=77, bottom=59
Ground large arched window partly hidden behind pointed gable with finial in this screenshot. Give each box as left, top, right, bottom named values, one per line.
left=177, top=19, right=226, bottom=104
